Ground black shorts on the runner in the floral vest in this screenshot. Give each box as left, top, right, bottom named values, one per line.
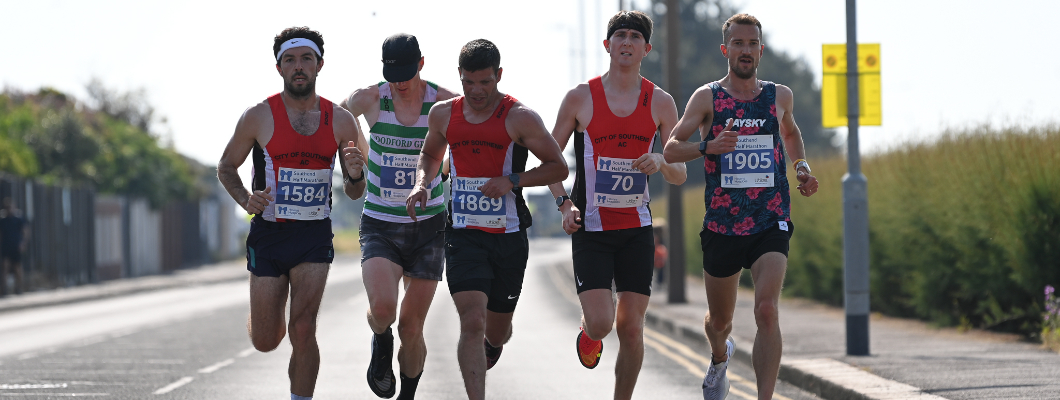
left=700, top=221, right=795, bottom=278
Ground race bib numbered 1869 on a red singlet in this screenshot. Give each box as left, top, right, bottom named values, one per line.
left=453, top=177, right=508, bottom=229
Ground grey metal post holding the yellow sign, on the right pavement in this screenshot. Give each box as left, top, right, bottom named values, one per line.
left=843, top=0, right=869, bottom=355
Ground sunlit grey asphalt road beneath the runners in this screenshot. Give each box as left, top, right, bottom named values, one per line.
left=0, top=241, right=815, bottom=400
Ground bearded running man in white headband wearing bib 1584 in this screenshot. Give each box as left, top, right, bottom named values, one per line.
left=217, top=27, right=367, bottom=400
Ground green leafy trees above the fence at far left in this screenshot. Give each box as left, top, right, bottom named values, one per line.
left=0, top=84, right=209, bottom=207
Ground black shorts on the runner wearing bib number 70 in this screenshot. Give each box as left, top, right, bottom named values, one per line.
left=570, top=226, right=655, bottom=296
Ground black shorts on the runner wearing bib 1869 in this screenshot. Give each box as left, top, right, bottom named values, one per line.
left=445, top=229, right=530, bottom=313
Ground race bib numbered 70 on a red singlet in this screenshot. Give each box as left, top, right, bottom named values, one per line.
left=593, top=157, right=648, bottom=208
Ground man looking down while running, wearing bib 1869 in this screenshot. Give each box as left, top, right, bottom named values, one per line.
left=406, top=39, right=567, bottom=400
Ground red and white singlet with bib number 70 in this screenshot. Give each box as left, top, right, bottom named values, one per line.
left=571, top=76, right=658, bottom=231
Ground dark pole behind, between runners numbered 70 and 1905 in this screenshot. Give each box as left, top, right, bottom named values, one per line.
left=660, top=0, right=687, bottom=303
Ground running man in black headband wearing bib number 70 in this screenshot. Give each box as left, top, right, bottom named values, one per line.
left=549, top=11, right=686, bottom=399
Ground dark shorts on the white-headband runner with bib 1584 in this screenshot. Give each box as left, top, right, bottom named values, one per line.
left=247, top=215, right=335, bottom=277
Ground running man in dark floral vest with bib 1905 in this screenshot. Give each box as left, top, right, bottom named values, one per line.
left=664, top=14, right=817, bottom=400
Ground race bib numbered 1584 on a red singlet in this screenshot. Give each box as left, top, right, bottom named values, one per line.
left=275, top=168, right=331, bottom=220
